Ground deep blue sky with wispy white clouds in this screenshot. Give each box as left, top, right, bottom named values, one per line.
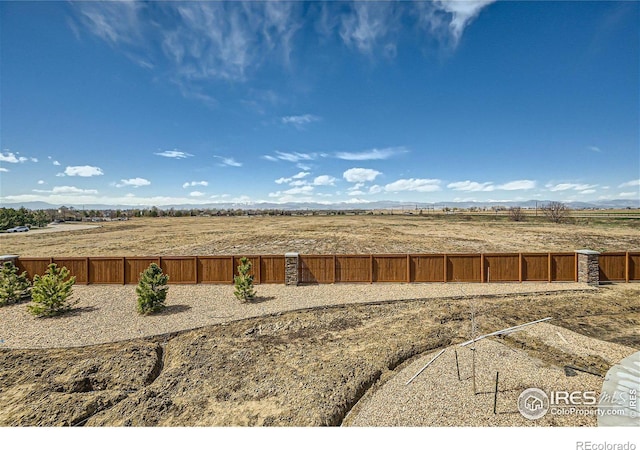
left=0, top=0, right=640, bottom=206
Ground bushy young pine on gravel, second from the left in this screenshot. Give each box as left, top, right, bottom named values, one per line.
left=27, top=264, right=78, bottom=317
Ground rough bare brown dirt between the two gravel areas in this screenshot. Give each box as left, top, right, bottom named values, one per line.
left=0, top=290, right=640, bottom=426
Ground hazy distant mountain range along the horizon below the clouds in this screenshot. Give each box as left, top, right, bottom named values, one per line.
left=0, top=199, right=640, bottom=211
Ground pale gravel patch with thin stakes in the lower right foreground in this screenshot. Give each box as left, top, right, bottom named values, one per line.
left=346, top=323, right=636, bottom=427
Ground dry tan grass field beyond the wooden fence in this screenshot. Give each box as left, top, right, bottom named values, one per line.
left=0, top=215, right=640, bottom=257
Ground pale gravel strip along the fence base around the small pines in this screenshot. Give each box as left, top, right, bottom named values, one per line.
left=0, top=283, right=593, bottom=348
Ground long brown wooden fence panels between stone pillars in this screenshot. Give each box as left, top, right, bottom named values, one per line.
left=16, top=252, right=640, bottom=284
